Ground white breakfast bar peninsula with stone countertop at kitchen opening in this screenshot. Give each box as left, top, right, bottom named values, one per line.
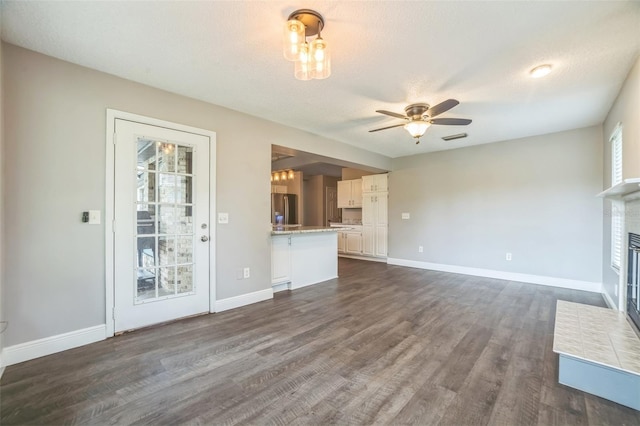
left=271, top=226, right=350, bottom=292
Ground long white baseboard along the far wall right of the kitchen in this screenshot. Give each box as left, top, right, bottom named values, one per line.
left=387, top=258, right=602, bottom=293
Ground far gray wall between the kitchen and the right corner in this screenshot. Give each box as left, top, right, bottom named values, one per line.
left=389, top=126, right=602, bottom=282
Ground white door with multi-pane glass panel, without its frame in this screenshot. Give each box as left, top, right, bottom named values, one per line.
left=113, top=118, right=215, bottom=333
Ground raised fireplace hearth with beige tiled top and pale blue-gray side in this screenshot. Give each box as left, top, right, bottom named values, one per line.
left=553, top=300, right=640, bottom=410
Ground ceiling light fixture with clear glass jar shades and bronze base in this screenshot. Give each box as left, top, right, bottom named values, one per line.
left=283, top=9, right=331, bottom=80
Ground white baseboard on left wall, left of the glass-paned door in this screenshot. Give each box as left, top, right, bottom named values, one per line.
left=2, top=324, right=107, bottom=367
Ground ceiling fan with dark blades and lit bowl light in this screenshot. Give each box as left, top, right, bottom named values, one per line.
left=369, top=99, right=471, bottom=144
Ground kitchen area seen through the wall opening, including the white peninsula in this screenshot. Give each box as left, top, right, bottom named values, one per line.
left=270, top=145, right=389, bottom=292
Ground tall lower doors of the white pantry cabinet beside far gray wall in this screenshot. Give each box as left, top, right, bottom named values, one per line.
left=362, top=192, right=389, bottom=257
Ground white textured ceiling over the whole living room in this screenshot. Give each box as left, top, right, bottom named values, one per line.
left=1, top=1, right=640, bottom=157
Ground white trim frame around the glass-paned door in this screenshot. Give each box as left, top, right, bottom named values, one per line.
left=104, top=108, right=217, bottom=337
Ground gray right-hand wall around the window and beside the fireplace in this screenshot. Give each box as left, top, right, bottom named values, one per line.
left=602, top=57, right=640, bottom=308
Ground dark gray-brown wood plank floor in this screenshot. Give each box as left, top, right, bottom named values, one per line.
left=0, top=259, right=640, bottom=425
